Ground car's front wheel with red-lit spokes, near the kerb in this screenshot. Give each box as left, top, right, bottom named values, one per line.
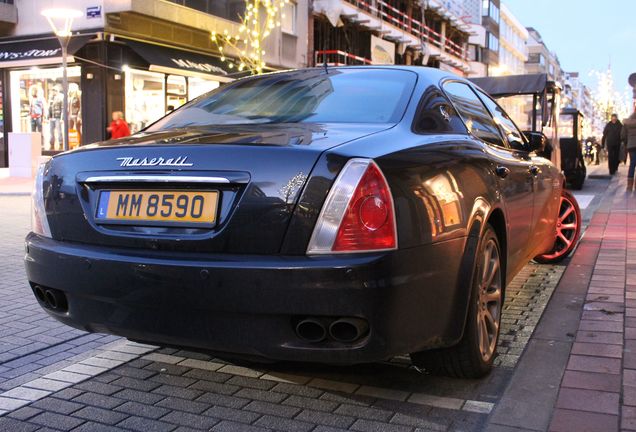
left=534, top=189, right=581, bottom=264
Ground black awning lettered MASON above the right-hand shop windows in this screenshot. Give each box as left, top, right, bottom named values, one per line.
left=126, top=41, right=232, bottom=82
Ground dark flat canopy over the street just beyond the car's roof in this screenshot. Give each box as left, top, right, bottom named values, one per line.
left=470, top=74, right=559, bottom=97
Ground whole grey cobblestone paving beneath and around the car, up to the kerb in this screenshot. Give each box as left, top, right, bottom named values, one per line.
left=0, top=196, right=565, bottom=432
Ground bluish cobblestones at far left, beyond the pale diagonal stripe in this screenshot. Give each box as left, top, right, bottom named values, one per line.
left=0, top=196, right=117, bottom=391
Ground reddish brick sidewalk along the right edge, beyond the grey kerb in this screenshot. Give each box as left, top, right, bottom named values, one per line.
left=549, top=167, right=636, bottom=432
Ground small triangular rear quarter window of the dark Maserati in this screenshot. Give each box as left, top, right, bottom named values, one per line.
left=413, top=86, right=466, bottom=134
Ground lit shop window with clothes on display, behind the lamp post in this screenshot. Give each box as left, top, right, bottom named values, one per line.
left=10, top=66, right=82, bottom=152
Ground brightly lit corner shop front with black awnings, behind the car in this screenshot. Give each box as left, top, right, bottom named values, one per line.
left=0, top=34, right=232, bottom=166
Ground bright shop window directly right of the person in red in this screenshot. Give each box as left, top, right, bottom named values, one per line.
left=126, top=69, right=166, bottom=133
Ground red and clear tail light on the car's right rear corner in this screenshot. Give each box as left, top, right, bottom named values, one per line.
left=307, top=158, right=397, bottom=254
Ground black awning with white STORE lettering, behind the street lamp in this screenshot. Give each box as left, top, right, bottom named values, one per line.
left=0, top=35, right=94, bottom=68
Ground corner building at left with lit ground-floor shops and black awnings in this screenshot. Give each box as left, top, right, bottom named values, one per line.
left=0, top=0, right=310, bottom=166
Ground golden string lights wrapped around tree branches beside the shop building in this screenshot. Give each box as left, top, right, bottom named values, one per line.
left=210, top=0, right=290, bottom=75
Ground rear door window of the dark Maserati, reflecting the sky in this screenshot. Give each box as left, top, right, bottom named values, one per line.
left=444, top=81, right=507, bottom=147
